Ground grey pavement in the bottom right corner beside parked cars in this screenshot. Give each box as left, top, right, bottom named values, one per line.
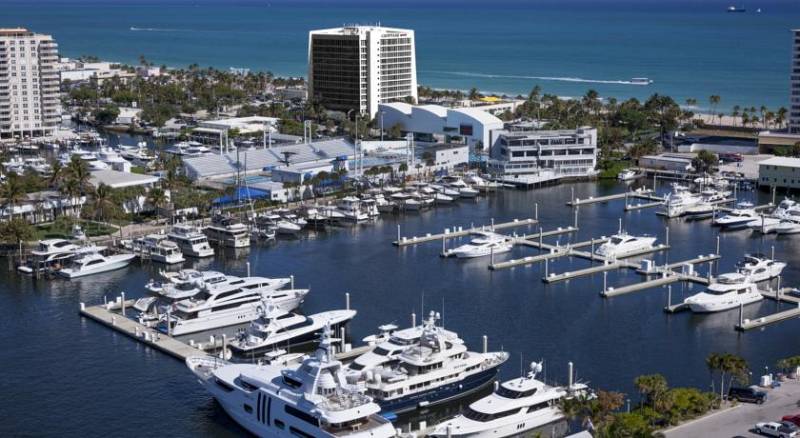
left=664, top=380, right=800, bottom=438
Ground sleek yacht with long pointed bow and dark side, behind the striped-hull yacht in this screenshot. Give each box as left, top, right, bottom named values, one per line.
left=230, top=300, right=356, bottom=357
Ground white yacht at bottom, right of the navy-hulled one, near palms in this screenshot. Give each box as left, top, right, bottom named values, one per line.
left=430, top=362, right=591, bottom=438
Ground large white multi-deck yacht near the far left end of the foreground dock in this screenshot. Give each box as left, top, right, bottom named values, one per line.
left=159, top=277, right=308, bottom=336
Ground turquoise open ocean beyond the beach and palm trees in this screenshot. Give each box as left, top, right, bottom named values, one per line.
left=6, top=0, right=800, bottom=109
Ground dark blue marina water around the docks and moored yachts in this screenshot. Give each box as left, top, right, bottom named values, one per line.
left=0, top=183, right=800, bottom=437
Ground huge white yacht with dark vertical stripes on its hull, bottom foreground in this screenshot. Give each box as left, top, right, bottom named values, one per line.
left=186, top=329, right=396, bottom=438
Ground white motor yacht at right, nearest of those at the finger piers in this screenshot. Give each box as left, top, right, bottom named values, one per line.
left=684, top=272, right=764, bottom=313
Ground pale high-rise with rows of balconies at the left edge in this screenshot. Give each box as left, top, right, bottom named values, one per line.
left=0, top=28, right=61, bottom=139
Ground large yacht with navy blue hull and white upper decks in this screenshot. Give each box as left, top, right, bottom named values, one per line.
left=361, top=315, right=508, bottom=413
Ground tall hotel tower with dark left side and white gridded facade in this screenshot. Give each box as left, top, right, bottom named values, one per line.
left=308, top=26, right=417, bottom=117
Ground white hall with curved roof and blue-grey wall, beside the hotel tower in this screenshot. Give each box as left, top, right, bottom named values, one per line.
left=378, top=102, right=503, bottom=147
